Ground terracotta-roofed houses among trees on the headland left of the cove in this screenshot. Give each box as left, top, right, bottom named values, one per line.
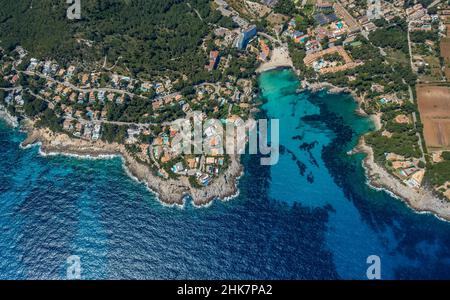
left=2, top=11, right=260, bottom=186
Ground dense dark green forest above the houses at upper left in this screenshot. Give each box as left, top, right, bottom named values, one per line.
left=0, top=0, right=220, bottom=77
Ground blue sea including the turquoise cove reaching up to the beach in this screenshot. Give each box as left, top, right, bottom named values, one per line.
left=0, top=71, right=450, bottom=279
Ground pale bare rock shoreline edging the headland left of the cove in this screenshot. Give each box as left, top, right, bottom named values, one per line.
left=21, top=126, right=243, bottom=206
